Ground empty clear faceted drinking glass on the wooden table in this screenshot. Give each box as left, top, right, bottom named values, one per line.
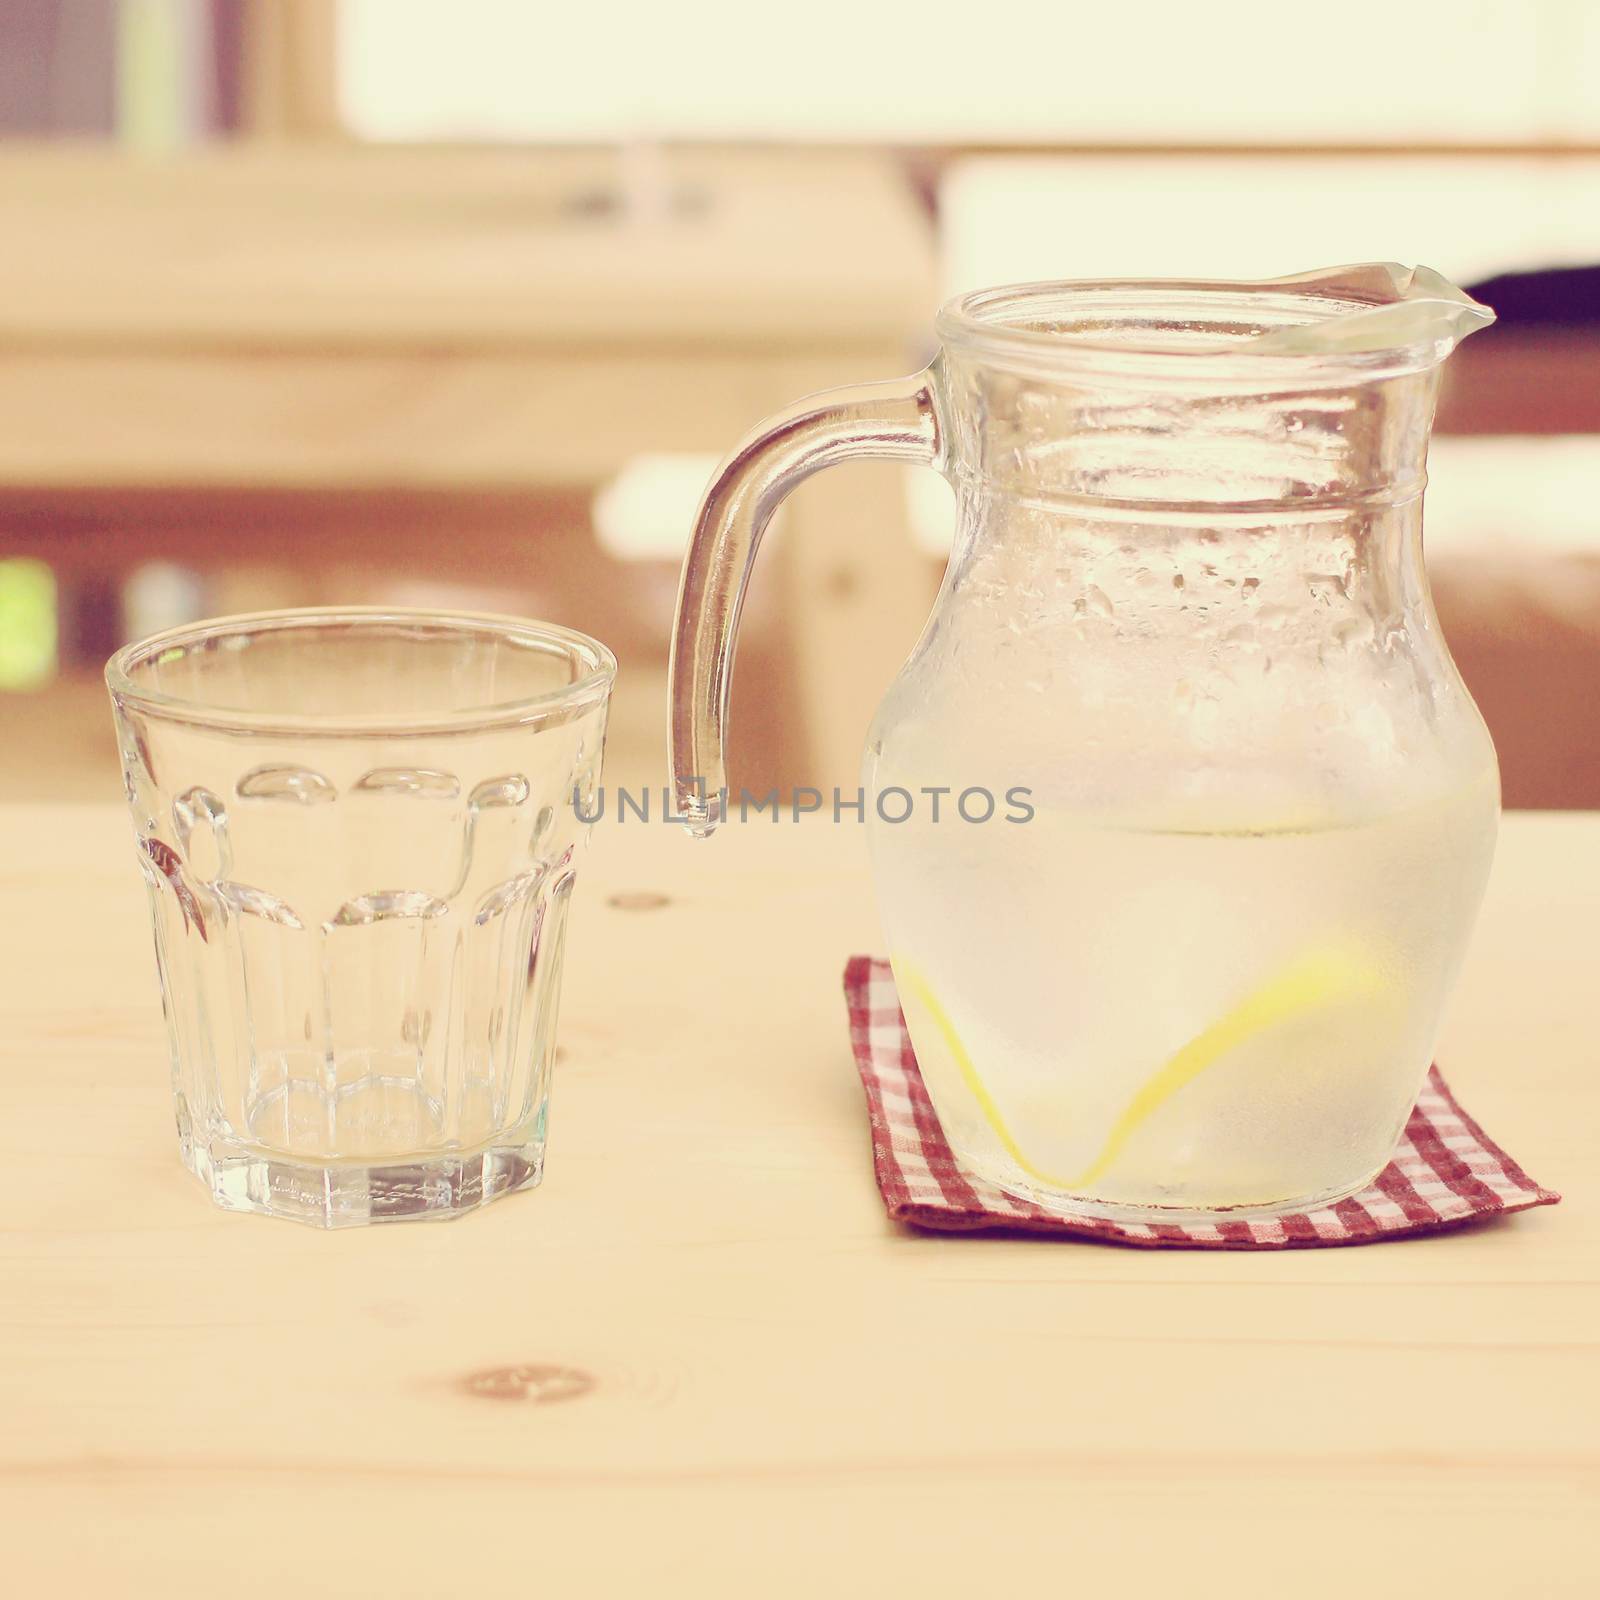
left=106, top=608, right=616, bottom=1227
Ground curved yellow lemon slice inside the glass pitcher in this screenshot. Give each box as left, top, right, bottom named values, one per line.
left=893, top=944, right=1384, bottom=1189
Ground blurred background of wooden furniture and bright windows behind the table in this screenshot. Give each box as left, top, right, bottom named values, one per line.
left=0, top=0, right=1600, bottom=806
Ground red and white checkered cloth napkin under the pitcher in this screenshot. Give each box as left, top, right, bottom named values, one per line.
left=845, top=955, right=1560, bottom=1250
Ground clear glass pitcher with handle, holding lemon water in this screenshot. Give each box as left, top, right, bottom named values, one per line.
left=672, top=264, right=1499, bottom=1221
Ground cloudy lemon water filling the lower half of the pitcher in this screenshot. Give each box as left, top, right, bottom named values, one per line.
left=874, top=765, right=1498, bottom=1216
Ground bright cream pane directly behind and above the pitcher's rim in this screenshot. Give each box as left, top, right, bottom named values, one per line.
left=939, top=157, right=1600, bottom=294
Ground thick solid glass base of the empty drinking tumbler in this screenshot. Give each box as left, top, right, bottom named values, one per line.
left=184, top=1142, right=544, bottom=1227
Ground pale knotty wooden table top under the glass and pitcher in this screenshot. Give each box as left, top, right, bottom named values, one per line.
left=0, top=806, right=1600, bottom=1600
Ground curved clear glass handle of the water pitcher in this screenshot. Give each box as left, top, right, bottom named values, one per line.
left=669, top=370, right=939, bottom=838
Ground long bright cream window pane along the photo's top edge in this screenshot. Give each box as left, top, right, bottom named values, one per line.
left=339, top=0, right=1600, bottom=146
